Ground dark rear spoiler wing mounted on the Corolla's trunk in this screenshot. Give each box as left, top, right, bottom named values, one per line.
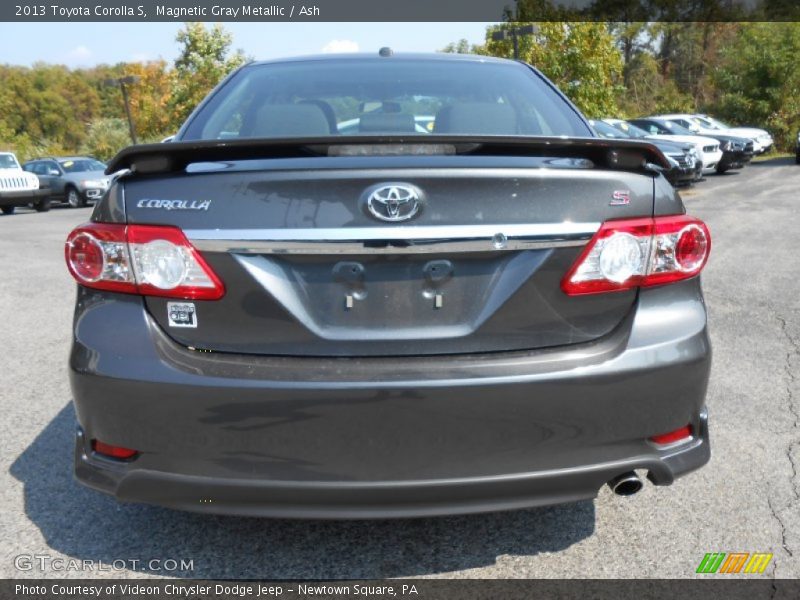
left=106, top=135, right=670, bottom=175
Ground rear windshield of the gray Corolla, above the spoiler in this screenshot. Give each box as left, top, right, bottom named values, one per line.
left=181, top=58, right=593, bottom=140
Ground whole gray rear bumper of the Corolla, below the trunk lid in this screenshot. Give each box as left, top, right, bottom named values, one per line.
left=70, top=280, right=711, bottom=518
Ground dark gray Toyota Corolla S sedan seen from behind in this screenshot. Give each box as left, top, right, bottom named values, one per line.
left=66, top=50, right=711, bottom=518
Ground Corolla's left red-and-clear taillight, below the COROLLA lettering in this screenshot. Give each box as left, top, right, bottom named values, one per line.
left=64, top=223, right=225, bottom=300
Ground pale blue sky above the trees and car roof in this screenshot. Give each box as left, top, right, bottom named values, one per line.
left=0, top=22, right=489, bottom=68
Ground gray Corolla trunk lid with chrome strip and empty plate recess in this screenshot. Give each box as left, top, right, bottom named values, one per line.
left=123, top=142, right=654, bottom=356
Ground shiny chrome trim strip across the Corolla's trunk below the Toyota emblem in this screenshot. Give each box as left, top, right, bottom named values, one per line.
left=184, top=223, right=600, bottom=254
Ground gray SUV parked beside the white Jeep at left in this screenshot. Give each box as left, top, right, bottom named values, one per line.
left=22, top=156, right=111, bottom=208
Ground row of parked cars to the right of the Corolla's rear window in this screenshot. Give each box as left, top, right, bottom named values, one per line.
left=590, top=114, right=772, bottom=185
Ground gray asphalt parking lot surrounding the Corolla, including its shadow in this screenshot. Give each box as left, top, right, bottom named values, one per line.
left=0, top=159, right=800, bottom=578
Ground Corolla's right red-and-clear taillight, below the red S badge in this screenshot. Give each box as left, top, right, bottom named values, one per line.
left=561, top=215, right=711, bottom=296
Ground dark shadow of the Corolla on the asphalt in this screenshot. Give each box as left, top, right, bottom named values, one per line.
left=11, top=403, right=595, bottom=579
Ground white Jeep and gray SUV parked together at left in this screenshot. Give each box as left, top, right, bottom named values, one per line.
left=0, top=152, right=111, bottom=214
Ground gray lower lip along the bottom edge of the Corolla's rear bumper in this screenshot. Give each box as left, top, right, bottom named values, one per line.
left=75, top=411, right=710, bottom=519
